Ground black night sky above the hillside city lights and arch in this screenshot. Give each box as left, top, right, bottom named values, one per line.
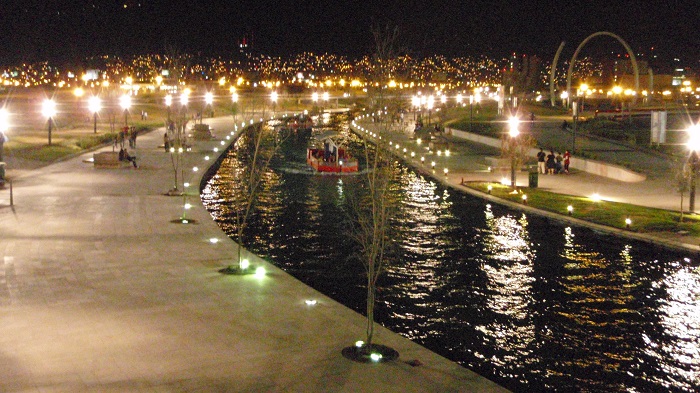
left=0, top=0, right=700, bottom=66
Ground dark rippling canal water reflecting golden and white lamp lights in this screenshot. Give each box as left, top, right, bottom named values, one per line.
left=202, top=116, right=700, bottom=392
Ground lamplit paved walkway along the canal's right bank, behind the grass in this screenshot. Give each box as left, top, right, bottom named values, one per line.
left=357, top=115, right=700, bottom=251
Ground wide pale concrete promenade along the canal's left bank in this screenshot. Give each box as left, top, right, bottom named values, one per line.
left=0, top=119, right=504, bottom=392
